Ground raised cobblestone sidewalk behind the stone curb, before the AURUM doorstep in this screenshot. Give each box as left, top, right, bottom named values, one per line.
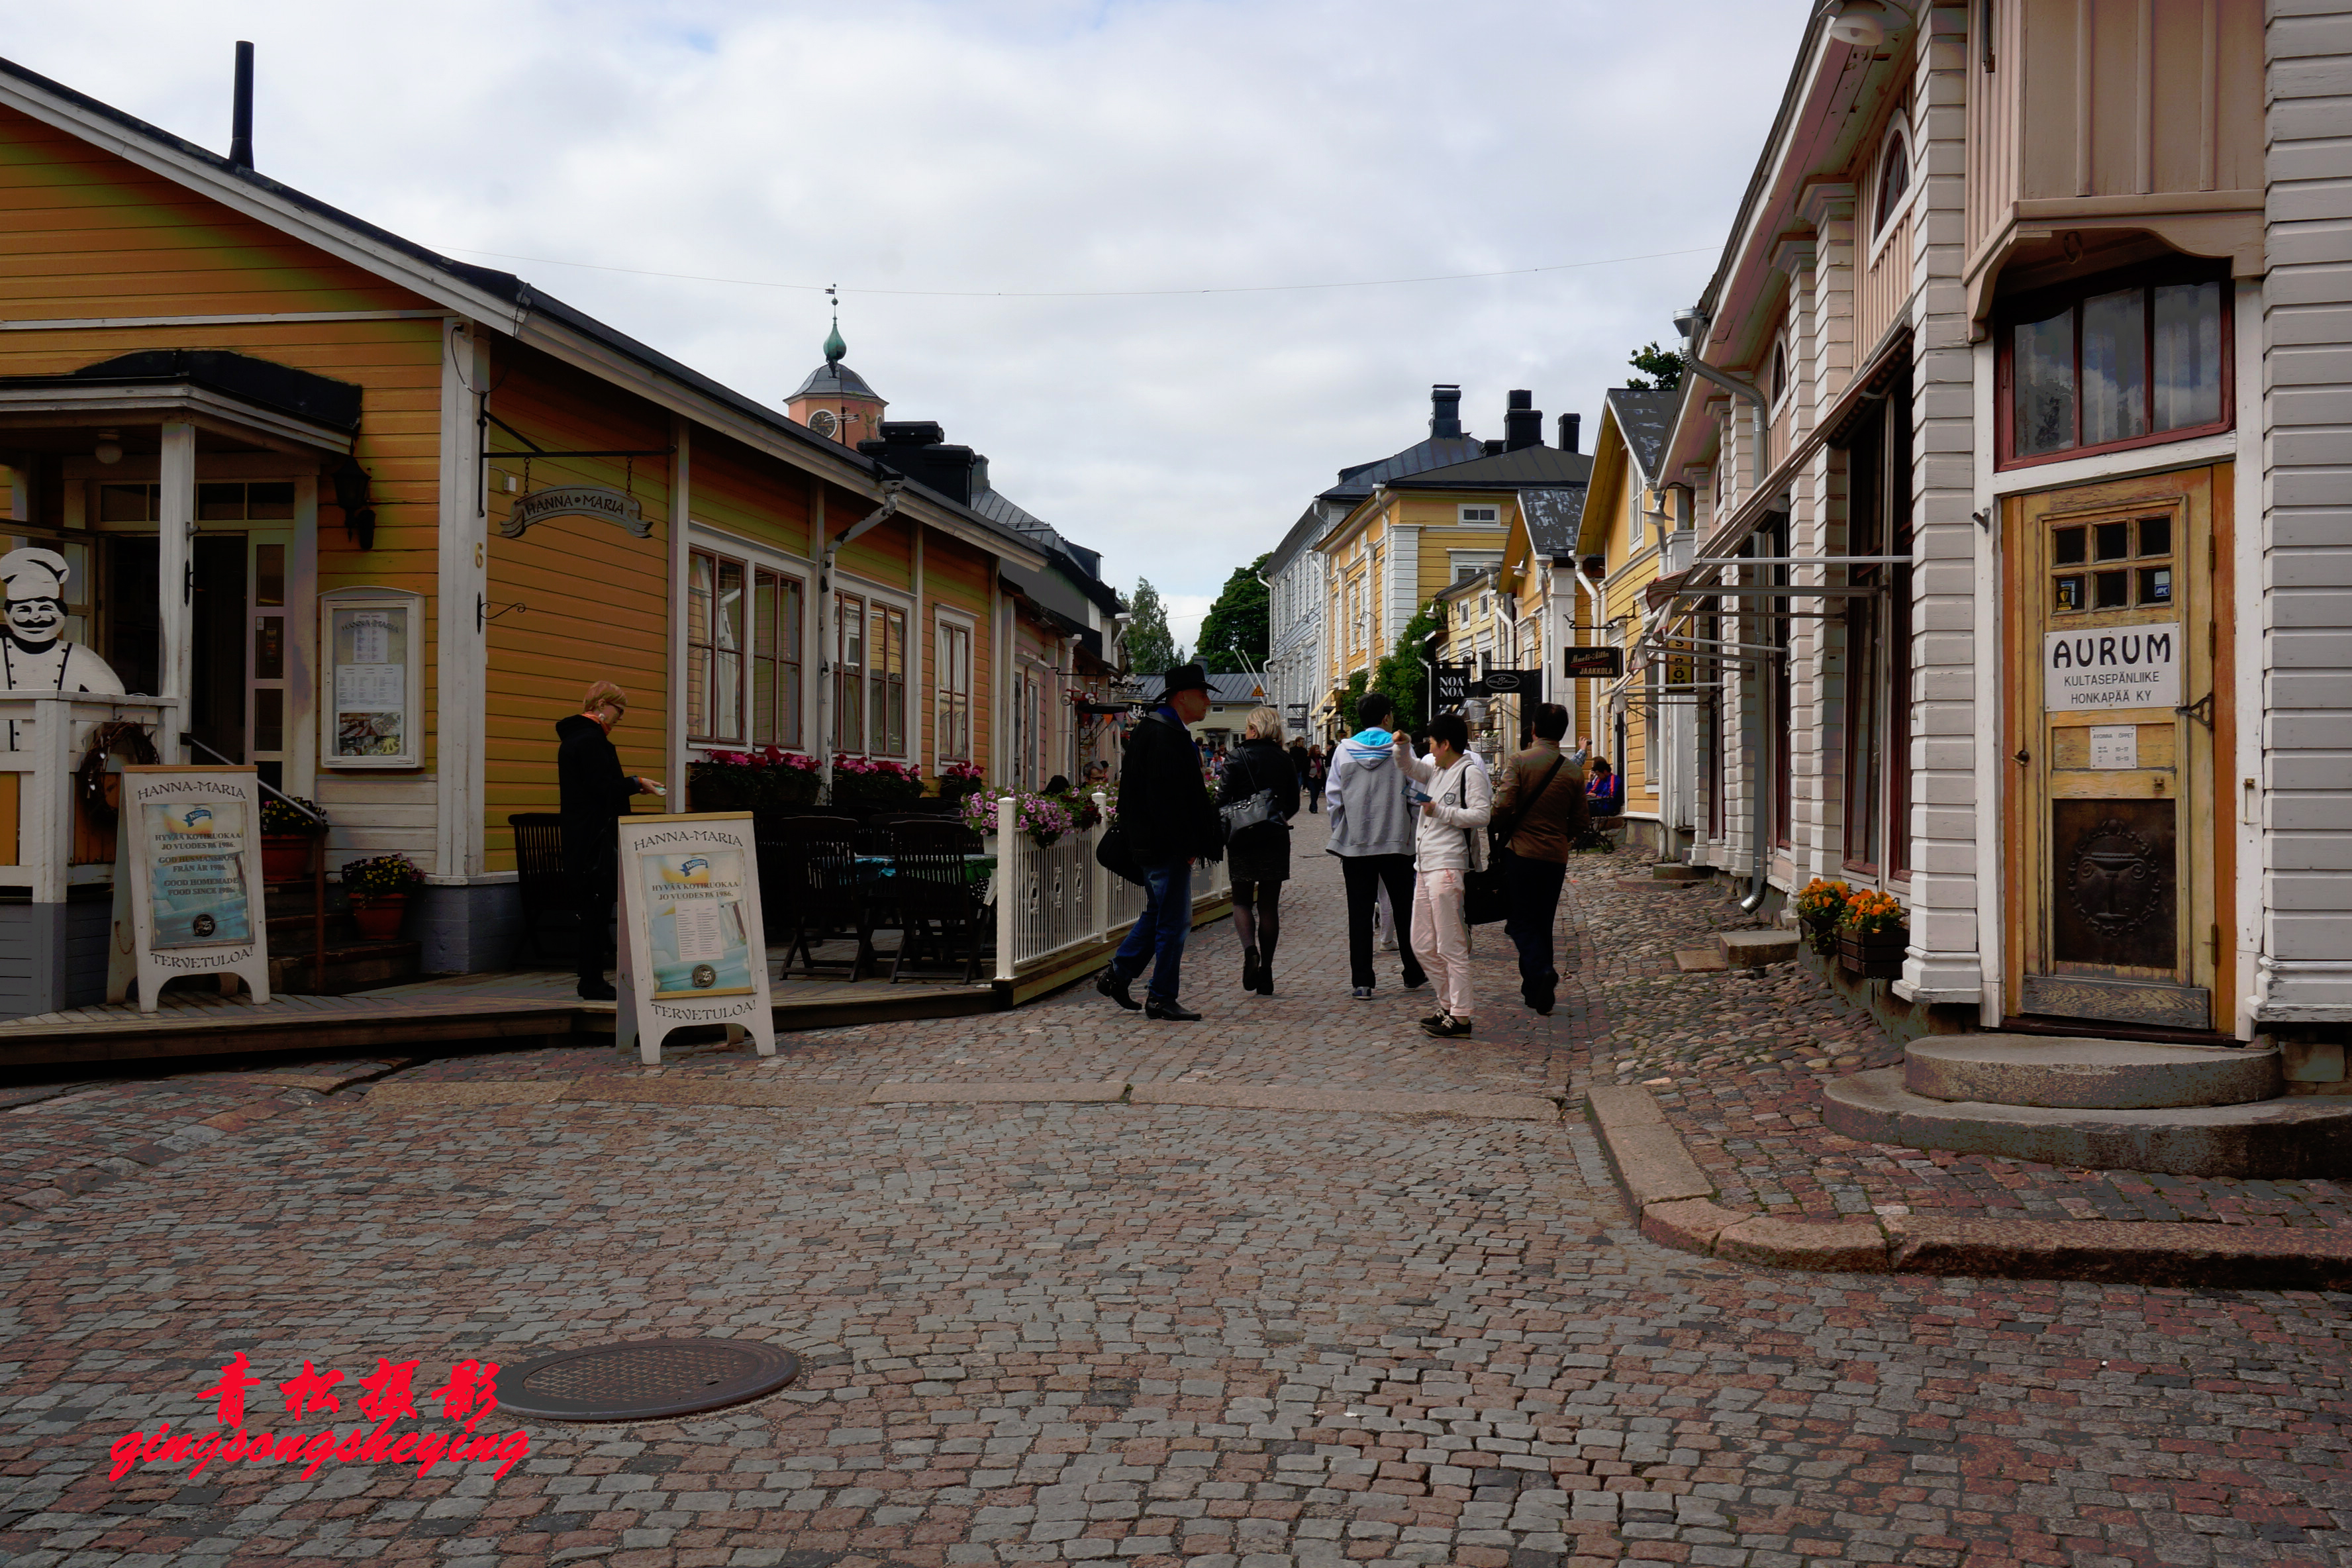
left=1569, top=851, right=2352, bottom=1227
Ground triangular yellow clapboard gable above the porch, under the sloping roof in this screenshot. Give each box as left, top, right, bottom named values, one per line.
left=0, top=108, right=428, bottom=320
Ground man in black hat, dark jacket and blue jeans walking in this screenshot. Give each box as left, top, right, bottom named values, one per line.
left=1094, top=665, right=1218, bottom=1022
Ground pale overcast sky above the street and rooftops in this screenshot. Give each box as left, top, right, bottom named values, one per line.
left=0, top=0, right=1808, bottom=642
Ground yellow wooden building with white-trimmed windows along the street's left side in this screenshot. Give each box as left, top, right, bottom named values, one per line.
left=0, top=61, right=1117, bottom=1016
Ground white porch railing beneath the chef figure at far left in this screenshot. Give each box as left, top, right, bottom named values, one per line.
left=0, top=693, right=179, bottom=903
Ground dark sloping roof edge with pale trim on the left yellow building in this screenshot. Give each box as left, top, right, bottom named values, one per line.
left=0, top=59, right=1042, bottom=567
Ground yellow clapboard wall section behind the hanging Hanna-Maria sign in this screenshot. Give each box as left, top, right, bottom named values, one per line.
left=468, top=348, right=682, bottom=872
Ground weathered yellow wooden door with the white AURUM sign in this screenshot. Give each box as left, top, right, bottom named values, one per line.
left=2004, top=467, right=2230, bottom=1030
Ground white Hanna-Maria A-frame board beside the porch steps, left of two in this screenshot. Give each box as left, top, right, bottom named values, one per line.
left=108, top=764, right=270, bottom=1013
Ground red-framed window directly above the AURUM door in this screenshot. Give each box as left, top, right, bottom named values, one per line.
left=2002, top=266, right=2230, bottom=463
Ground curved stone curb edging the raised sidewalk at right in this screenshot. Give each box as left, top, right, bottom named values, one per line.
left=1588, top=1086, right=2352, bottom=1291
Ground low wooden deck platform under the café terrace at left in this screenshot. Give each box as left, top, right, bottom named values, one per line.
left=0, top=971, right=1011, bottom=1069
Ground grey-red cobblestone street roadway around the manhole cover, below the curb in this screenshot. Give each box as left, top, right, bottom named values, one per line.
left=0, top=820, right=2352, bottom=1568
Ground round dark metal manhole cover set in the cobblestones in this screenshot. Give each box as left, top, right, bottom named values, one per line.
left=499, top=1340, right=800, bottom=1420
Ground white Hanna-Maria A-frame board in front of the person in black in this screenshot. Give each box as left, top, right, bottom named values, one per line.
left=614, top=811, right=776, bottom=1067
